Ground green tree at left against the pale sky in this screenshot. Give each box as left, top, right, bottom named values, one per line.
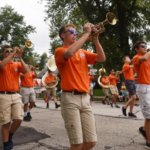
left=0, top=5, right=35, bottom=62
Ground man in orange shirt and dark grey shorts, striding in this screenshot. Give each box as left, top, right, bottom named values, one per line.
left=122, top=56, right=136, bottom=118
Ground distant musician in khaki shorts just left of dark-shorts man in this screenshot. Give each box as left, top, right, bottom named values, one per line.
left=109, top=69, right=120, bottom=108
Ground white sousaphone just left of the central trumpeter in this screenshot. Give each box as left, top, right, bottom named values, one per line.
left=42, top=58, right=59, bottom=88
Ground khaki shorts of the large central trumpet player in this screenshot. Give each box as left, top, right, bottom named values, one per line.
left=61, top=92, right=97, bottom=145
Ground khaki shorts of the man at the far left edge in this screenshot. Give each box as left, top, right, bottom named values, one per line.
left=0, top=93, right=24, bottom=125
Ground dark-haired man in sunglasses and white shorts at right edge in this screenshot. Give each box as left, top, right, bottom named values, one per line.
left=133, top=41, right=150, bottom=149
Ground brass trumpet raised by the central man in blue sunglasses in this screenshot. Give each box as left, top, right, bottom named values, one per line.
left=78, top=12, right=117, bottom=40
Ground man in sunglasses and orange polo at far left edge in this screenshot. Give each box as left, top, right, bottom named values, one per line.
left=0, top=45, right=28, bottom=150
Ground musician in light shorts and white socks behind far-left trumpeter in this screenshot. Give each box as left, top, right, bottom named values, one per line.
left=20, top=65, right=38, bottom=121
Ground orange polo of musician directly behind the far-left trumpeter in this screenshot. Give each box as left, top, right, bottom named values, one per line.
left=20, top=72, right=36, bottom=87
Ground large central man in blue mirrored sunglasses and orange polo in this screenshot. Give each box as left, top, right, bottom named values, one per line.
left=55, top=23, right=106, bottom=150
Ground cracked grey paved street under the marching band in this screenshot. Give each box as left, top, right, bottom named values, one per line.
left=0, top=100, right=145, bottom=150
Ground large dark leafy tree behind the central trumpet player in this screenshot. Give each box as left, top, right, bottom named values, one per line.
left=43, top=0, right=150, bottom=70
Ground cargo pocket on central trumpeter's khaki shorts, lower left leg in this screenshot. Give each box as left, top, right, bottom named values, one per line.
left=65, top=122, right=78, bottom=140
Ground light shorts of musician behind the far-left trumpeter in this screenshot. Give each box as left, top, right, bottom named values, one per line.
left=20, top=87, right=36, bottom=104
